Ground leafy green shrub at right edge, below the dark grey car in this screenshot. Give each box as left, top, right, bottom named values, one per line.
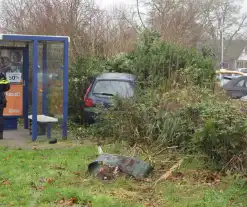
left=188, top=100, right=247, bottom=170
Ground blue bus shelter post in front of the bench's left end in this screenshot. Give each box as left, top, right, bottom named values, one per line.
left=32, top=40, right=39, bottom=141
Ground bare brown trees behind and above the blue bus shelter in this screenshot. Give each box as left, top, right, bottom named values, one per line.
left=0, top=0, right=136, bottom=57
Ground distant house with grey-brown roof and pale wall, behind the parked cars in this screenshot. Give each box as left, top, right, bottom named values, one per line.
left=198, top=40, right=247, bottom=70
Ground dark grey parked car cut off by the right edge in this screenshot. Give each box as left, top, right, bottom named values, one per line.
left=228, top=79, right=247, bottom=99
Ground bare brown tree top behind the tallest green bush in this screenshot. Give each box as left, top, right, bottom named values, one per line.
left=146, top=0, right=208, bottom=46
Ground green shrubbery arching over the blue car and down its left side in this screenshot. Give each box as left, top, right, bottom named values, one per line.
left=69, top=31, right=214, bottom=119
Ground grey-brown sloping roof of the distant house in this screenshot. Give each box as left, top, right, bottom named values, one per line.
left=198, top=40, right=247, bottom=61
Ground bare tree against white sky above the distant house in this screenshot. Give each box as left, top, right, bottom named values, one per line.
left=198, top=0, right=247, bottom=60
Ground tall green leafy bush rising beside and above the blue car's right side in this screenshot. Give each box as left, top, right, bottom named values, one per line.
left=103, top=31, right=215, bottom=87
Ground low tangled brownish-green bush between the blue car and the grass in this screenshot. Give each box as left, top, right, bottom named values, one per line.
left=92, top=79, right=247, bottom=168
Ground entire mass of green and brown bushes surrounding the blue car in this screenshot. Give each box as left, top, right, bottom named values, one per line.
left=70, top=31, right=247, bottom=171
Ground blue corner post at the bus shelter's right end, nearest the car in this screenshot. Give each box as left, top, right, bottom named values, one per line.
left=62, top=39, right=69, bottom=138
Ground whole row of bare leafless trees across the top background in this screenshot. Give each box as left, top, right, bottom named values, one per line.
left=5, top=0, right=247, bottom=57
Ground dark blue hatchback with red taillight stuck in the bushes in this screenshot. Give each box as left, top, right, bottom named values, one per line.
left=83, top=73, right=136, bottom=124
